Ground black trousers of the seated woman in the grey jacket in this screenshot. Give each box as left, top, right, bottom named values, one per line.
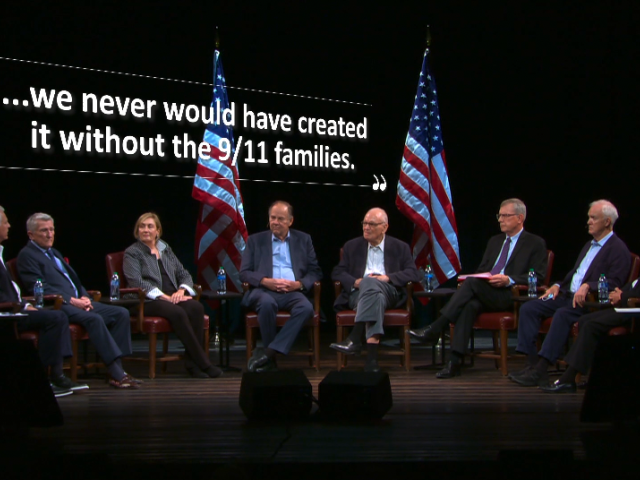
left=136, top=300, right=211, bottom=370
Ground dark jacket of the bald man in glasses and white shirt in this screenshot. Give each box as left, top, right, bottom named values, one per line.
left=331, top=235, right=421, bottom=311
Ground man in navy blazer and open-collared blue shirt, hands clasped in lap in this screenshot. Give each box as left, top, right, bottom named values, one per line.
left=240, top=201, right=322, bottom=372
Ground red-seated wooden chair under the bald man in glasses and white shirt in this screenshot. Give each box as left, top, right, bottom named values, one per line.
left=334, top=248, right=413, bottom=371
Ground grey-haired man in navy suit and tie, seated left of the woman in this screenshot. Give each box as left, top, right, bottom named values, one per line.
left=17, top=213, right=140, bottom=388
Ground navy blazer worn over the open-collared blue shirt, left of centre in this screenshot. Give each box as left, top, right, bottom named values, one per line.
left=240, top=229, right=322, bottom=304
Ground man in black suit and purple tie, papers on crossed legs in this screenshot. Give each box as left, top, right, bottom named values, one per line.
left=409, top=198, right=547, bottom=378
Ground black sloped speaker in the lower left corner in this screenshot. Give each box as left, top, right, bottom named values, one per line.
left=0, top=340, right=64, bottom=427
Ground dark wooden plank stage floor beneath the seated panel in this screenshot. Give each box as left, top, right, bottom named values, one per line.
left=4, top=338, right=636, bottom=479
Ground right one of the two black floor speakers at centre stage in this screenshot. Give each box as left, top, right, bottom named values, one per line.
left=318, top=371, right=393, bottom=419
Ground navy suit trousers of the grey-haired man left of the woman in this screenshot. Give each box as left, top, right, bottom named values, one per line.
left=60, top=302, right=131, bottom=365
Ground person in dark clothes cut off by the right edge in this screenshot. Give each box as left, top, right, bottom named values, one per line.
left=540, top=278, right=640, bottom=393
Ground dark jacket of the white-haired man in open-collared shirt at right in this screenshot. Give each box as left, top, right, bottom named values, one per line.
left=560, top=233, right=631, bottom=294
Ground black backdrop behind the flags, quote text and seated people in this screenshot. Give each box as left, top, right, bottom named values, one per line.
left=0, top=1, right=640, bottom=296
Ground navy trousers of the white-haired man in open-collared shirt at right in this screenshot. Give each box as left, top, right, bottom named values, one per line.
left=516, top=295, right=588, bottom=363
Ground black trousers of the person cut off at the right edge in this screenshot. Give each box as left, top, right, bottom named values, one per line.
left=564, top=308, right=632, bottom=374
